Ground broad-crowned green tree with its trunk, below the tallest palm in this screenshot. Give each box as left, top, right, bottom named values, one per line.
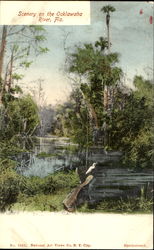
left=68, top=37, right=122, bottom=145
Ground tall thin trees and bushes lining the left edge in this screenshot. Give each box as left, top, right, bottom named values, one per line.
left=0, top=25, right=52, bottom=211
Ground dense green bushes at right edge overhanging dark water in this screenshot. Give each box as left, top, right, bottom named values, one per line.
left=122, top=76, right=154, bottom=167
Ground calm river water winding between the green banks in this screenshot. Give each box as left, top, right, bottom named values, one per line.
left=16, top=136, right=153, bottom=200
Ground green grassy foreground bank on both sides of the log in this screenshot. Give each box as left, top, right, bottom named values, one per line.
left=0, top=161, right=153, bottom=213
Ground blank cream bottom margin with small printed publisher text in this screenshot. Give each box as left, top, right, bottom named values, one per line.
left=0, top=211, right=153, bottom=249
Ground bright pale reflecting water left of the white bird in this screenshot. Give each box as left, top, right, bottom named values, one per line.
left=17, top=137, right=80, bottom=177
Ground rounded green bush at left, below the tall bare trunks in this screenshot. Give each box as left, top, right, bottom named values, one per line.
left=0, top=95, right=39, bottom=139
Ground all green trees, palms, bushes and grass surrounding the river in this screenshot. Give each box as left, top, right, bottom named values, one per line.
left=0, top=12, right=154, bottom=212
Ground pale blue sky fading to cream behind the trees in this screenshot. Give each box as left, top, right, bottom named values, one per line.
left=13, top=1, right=154, bottom=105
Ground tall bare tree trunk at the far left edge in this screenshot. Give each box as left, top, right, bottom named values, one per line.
left=0, top=25, right=7, bottom=104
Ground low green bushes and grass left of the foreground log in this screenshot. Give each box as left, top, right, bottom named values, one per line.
left=0, top=153, right=79, bottom=211
